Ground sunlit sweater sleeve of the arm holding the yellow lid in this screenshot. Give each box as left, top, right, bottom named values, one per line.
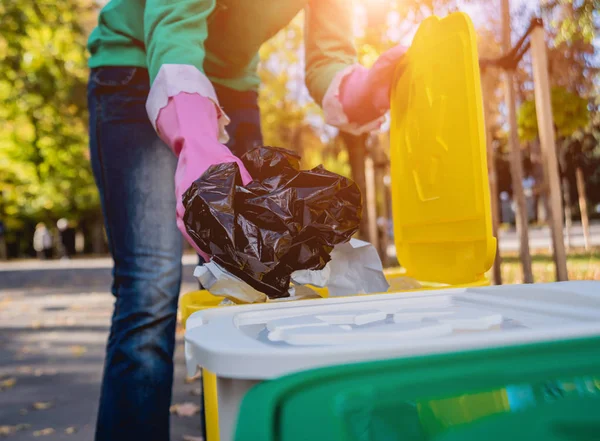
left=305, top=0, right=357, bottom=104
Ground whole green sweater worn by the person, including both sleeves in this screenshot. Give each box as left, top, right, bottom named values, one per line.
left=88, top=0, right=356, bottom=103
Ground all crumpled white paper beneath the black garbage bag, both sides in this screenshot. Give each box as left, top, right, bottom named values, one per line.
left=194, top=239, right=389, bottom=304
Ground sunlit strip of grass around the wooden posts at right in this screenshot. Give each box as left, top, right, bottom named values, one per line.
left=494, top=248, right=600, bottom=284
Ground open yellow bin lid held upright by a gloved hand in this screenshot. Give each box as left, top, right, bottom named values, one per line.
left=390, top=13, right=496, bottom=285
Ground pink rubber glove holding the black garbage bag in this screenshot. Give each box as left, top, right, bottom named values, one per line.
left=156, top=93, right=252, bottom=262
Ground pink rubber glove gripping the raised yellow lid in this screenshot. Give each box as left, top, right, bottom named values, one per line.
left=339, top=45, right=407, bottom=126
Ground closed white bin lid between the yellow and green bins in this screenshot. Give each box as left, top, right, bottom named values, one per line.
left=185, top=282, right=600, bottom=380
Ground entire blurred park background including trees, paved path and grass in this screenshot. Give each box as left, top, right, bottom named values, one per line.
left=0, top=0, right=600, bottom=441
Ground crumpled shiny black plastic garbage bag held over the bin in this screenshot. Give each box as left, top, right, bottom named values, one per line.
left=183, top=147, right=362, bottom=298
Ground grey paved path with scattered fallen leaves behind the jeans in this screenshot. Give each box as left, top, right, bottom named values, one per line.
left=0, top=256, right=201, bottom=441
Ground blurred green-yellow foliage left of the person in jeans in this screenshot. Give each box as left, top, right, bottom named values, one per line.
left=0, top=0, right=98, bottom=229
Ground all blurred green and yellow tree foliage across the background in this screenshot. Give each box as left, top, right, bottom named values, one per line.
left=0, top=0, right=600, bottom=254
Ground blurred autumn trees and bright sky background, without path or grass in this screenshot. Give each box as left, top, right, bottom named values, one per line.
left=0, top=0, right=600, bottom=278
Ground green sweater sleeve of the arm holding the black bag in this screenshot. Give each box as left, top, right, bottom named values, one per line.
left=144, top=0, right=215, bottom=82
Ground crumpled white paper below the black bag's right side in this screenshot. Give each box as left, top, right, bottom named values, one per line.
left=292, top=239, right=390, bottom=297
